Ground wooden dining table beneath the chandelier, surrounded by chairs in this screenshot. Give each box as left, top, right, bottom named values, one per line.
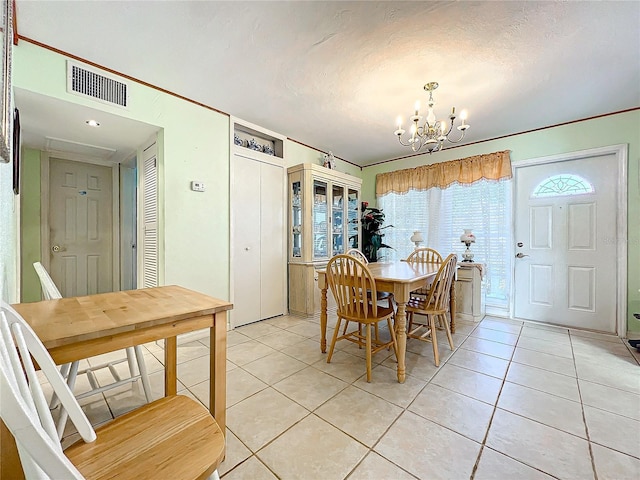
left=318, top=261, right=456, bottom=383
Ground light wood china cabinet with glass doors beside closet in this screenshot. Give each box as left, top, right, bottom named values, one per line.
left=287, top=164, right=362, bottom=315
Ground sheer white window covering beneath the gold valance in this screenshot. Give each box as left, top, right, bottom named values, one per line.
left=378, top=180, right=513, bottom=309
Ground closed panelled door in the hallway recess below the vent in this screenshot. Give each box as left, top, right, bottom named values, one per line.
left=49, top=158, right=113, bottom=297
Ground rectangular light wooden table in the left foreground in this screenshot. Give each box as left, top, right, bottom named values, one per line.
left=2, top=285, right=233, bottom=478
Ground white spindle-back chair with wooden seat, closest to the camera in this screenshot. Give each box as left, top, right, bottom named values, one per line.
left=0, top=302, right=225, bottom=480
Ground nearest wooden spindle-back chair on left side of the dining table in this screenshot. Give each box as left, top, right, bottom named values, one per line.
left=326, top=255, right=398, bottom=382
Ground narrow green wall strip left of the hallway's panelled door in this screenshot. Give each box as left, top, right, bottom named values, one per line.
left=20, top=148, right=42, bottom=302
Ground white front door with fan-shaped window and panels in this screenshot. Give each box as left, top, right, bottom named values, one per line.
left=514, top=155, right=618, bottom=332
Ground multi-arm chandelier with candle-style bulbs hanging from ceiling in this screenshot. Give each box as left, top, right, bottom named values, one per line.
left=394, top=82, right=469, bottom=153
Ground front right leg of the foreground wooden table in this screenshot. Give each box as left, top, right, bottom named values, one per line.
left=209, top=312, right=227, bottom=435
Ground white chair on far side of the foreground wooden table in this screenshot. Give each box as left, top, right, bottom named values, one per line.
left=33, top=262, right=153, bottom=438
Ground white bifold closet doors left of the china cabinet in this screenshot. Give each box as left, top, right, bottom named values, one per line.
left=231, top=155, right=286, bottom=327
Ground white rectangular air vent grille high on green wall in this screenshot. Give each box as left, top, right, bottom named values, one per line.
left=67, top=61, right=129, bottom=108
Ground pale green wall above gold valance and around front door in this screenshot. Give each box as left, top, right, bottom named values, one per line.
left=362, top=110, right=640, bottom=333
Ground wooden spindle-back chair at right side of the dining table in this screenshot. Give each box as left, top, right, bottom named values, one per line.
left=407, top=254, right=458, bottom=367
